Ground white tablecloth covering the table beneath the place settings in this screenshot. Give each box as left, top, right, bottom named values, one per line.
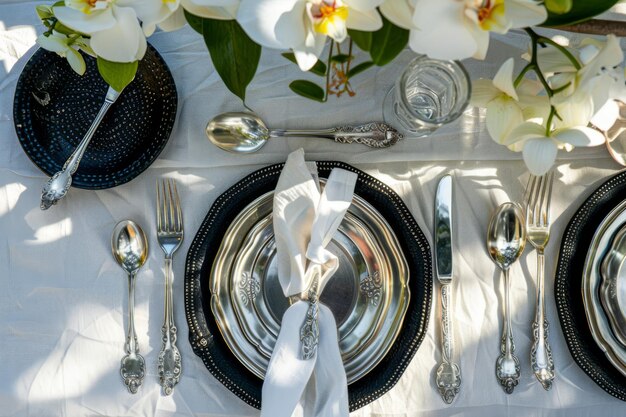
left=0, top=0, right=626, bottom=417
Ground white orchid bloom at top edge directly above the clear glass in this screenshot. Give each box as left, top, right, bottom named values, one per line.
left=409, top=0, right=548, bottom=59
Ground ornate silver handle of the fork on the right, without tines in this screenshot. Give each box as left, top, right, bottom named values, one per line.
left=530, top=250, right=554, bottom=391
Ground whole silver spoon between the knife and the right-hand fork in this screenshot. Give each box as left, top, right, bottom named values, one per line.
left=487, top=203, right=526, bottom=394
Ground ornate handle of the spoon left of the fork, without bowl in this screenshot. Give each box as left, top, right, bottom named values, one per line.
left=120, top=273, right=146, bottom=394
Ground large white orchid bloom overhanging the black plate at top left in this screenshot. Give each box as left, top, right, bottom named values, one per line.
left=53, top=0, right=147, bottom=62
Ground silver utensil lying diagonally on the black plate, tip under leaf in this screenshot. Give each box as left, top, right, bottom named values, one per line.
left=39, top=86, right=121, bottom=210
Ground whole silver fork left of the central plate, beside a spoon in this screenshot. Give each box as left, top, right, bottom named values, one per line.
left=156, top=179, right=184, bottom=395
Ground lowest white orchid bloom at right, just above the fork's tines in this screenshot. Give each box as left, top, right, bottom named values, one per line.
left=505, top=121, right=605, bottom=175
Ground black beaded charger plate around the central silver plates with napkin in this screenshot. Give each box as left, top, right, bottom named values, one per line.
left=185, top=161, right=433, bottom=411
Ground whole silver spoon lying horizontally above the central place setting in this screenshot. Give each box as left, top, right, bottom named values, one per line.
left=206, top=112, right=403, bottom=153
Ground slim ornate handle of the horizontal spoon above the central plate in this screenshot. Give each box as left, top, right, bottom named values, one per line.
left=269, top=123, right=403, bottom=148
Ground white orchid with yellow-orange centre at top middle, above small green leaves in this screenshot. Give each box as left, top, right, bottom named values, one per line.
left=239, top=0, right=383, bottom=71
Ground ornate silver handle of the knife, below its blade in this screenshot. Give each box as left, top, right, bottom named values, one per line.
left=436, top=284, right=461, bottom=404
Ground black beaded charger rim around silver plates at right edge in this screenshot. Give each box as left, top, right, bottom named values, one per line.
left=554, top=172, right=626, bottom=401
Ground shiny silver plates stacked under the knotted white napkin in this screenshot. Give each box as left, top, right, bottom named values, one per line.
left=209, top=180, right=410, bottom=384
